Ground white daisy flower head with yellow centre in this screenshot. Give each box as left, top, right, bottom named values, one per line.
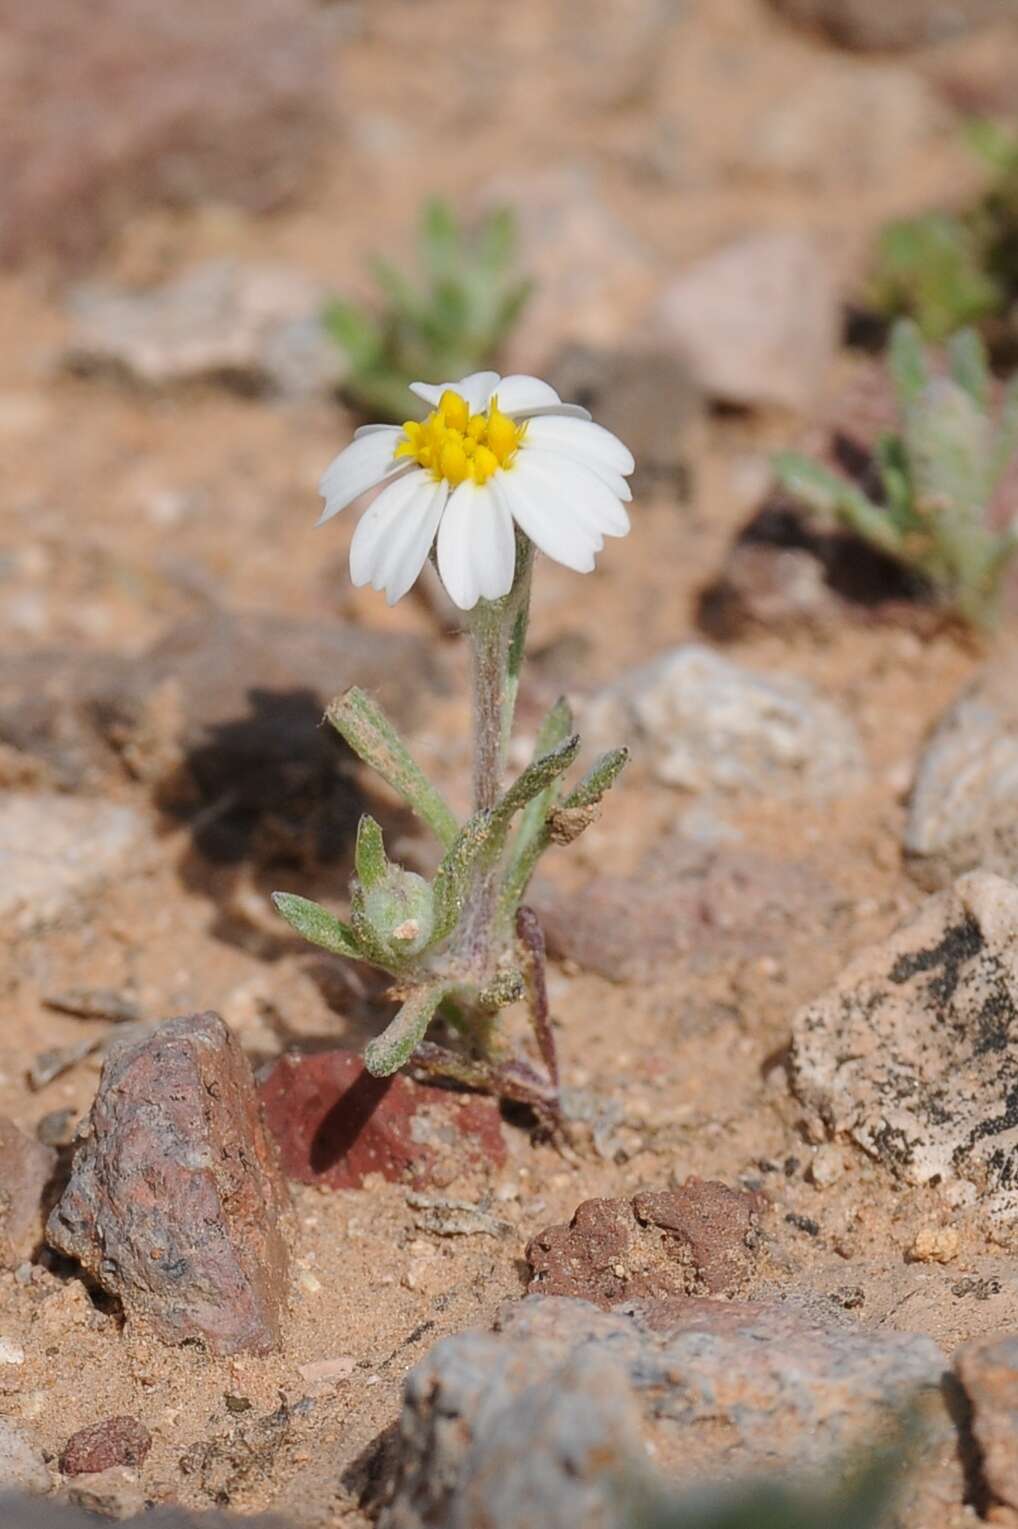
left=318, top=372, right=634, bottom=610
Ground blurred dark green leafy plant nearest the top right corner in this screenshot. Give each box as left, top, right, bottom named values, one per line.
left=868, top=119, right=1018, bottom=342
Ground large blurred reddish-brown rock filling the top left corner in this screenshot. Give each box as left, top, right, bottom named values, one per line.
left=0, top=0, right=332, bottom=265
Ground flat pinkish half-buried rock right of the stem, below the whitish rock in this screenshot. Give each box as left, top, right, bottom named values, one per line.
left=532, top=831, right=838, bottom=982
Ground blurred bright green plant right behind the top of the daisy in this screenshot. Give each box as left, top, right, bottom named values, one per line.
left=324, top=199, right=532, bottom=424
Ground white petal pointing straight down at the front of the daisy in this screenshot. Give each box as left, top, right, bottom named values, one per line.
left=439, top=479, right=517, bottom=610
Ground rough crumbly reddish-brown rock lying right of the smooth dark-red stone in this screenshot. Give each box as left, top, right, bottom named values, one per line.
left=526, top=1179, right=760, bottom=1309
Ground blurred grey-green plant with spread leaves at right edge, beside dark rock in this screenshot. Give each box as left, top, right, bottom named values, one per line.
left=773, top=320, right=1018, bottom=627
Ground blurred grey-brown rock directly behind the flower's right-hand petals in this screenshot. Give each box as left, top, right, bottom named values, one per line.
left=547, top=344, right=702, bottom=492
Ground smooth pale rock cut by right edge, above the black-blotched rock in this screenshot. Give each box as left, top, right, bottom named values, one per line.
left=903, top=662, right=1018, bottom=888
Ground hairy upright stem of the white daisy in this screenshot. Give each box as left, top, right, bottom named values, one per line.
left=457, top=537, right=533, bottom=985
